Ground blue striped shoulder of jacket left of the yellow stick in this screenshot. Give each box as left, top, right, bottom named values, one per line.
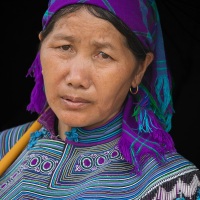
left=0, top=122, right=33, bottom=160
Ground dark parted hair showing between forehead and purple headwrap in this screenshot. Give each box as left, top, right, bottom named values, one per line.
left=41, top=4, right=149, bottom=60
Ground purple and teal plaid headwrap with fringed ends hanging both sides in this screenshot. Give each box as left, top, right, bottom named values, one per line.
left=27, top=0, right=175, bottom=172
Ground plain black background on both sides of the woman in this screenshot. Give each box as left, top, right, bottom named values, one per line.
left=0, top=0, right=200, bottom=168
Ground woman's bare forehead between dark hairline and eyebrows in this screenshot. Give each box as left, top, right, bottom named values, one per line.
left=53, top=8, right=126, bottom=43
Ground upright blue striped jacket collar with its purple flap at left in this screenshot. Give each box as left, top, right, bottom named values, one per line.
left=39, top=109, right=122, bottom=146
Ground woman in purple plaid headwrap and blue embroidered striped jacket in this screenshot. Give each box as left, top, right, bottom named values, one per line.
left=0, top=0, right=200, bottom=200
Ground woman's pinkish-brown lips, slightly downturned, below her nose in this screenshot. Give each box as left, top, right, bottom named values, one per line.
left=61, top=96, right=91, bottom=109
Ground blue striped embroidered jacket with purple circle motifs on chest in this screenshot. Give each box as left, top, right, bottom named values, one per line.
left=0, top=110, right=200, bottom=200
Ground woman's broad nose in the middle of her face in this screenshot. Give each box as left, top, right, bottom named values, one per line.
left=66, top=56, right=91, bottom=89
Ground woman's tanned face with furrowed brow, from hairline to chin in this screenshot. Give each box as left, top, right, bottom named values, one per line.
left=40, top=9, right=147, bottom=128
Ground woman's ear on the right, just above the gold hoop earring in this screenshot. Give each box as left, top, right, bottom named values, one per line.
left=131, top=52, right=154, bottom=88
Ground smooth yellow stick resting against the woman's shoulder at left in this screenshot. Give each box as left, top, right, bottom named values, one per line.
left=0, top=120, right=42, bottom=176
